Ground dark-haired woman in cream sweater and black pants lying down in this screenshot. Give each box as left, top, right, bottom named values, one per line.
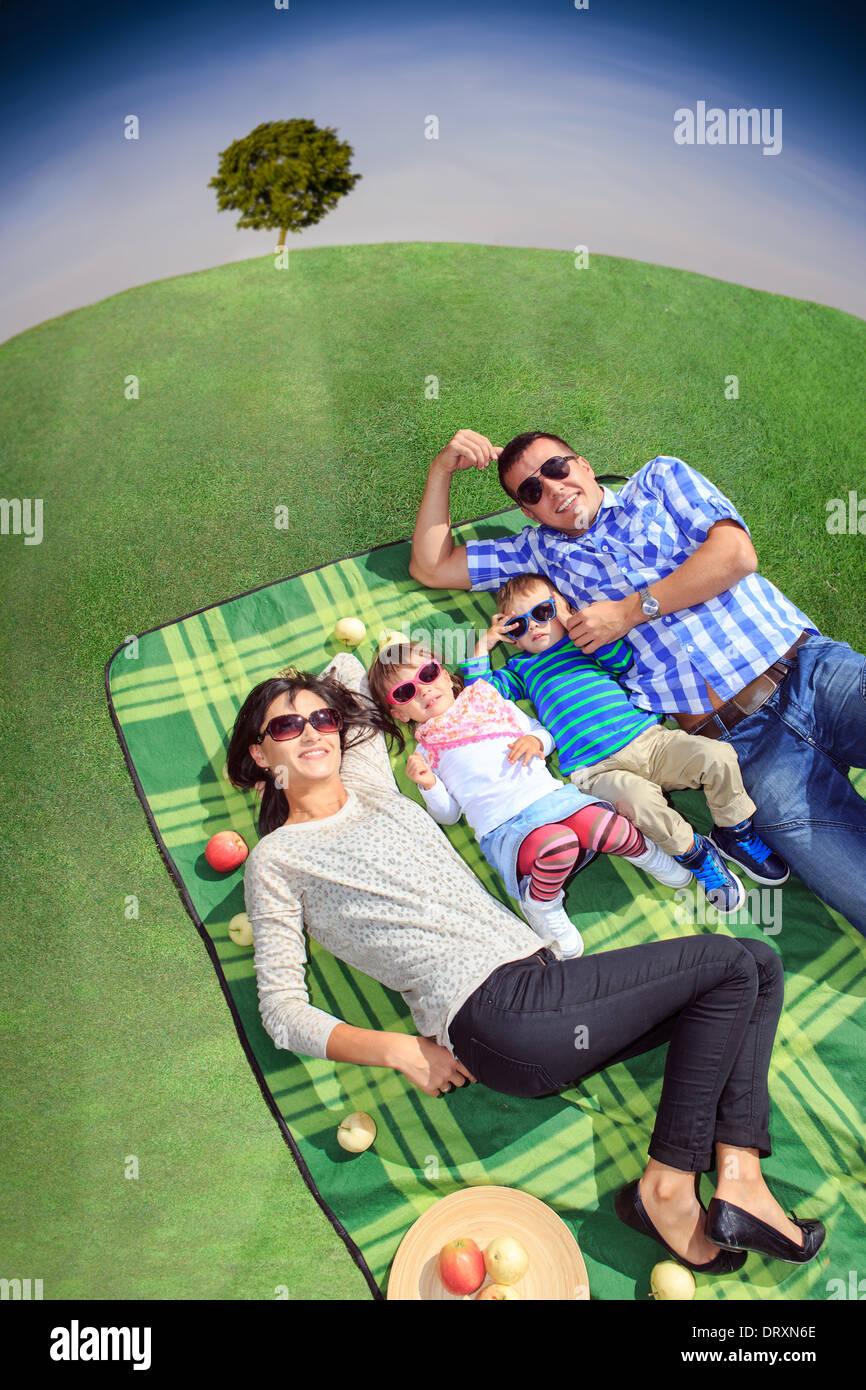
left=228, top=644, right=824, bottom=1273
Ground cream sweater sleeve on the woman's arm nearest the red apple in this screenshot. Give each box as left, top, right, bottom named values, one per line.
left=243, top=835, right=341, bottom=1058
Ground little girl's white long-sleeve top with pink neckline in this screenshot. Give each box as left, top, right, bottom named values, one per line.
left=418, top=701, right=563, bottom=840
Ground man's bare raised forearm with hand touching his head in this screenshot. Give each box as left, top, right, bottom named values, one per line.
left=409, top=430, right=502, bottom=589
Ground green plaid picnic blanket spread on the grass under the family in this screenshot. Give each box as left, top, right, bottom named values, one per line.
left=106, top=512, right=866, bottom=1298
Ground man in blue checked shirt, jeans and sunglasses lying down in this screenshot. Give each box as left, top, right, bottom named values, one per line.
left=410, top=430, right=866, bottom=935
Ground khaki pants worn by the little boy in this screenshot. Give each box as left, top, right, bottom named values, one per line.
left=571, top=724, right=755, bottom=855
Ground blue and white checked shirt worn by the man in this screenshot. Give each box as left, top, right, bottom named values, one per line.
left=467, top=457, right=817, bottom=714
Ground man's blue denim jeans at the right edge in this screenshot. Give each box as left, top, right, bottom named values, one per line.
left=706, top=637, right=866, bottom=935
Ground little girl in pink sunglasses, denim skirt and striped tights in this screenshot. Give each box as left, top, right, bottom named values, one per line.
left=368, top=644, right=691, bottom=959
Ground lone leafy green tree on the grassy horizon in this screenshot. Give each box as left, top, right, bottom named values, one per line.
left=209, top=118, right=361, bottom=249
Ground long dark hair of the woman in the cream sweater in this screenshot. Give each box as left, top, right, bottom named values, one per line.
left=225, top=667, right=405, bottom=835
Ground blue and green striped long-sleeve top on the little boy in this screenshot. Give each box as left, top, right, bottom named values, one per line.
left=461, top=637, right=660, bottom=777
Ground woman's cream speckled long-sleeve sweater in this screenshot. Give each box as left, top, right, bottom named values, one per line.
left=245, top=653, right=559, bottom=1058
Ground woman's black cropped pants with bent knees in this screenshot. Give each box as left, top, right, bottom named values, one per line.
left=449, top=935, right=784, bottom=1172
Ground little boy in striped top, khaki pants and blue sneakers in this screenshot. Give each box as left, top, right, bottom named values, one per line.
left=463, top=574, right=788, bottom=913
